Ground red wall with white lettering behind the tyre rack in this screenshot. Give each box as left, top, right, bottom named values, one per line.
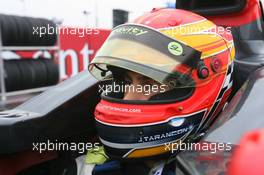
left=3, top=28, right=110, bottom=80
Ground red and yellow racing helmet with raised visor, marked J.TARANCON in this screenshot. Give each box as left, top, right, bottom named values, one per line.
left=88, top=9, right=234, bottom=159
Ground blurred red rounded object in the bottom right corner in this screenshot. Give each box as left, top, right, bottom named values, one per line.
left=227, top=129, right=264, bottom=175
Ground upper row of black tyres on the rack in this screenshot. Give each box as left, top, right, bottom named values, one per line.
left=0, top=14, right=57, bottom=46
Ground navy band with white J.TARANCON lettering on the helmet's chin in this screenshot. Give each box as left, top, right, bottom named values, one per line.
left=96, top=110, right=207, bottom=158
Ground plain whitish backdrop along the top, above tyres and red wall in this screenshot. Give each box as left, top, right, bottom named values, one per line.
left=0, top=0, right=174, bottom=28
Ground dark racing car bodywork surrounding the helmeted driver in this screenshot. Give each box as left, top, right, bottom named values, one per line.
left=0, top=0, right=264, bottom=175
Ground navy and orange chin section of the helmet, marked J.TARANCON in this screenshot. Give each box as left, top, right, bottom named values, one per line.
left=96, top=105, right=207, bottom=159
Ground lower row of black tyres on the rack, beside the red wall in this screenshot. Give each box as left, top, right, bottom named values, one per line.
left=4, top=58, right=59, bottom=91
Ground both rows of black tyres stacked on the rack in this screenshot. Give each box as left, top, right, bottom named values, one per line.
left=0, top=15, right=59, bottom=91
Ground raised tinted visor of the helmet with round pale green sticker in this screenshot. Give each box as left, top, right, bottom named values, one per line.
left=89, top=24, right=203, bottom=87
